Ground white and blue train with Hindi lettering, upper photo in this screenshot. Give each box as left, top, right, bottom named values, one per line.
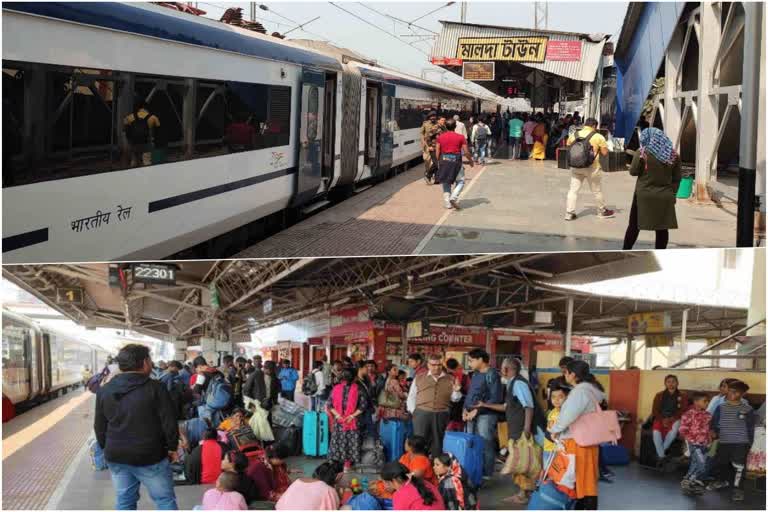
left=2, top=2, right=500, bottom=263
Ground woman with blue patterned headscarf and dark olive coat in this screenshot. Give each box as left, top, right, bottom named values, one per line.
left=624, top=128, right=681, bottom=250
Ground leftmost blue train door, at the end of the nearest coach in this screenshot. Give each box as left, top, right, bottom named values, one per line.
left=292, top=69, right=325, bottom=206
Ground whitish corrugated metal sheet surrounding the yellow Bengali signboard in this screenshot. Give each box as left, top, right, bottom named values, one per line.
left=431, top=21, right=605, bottom=82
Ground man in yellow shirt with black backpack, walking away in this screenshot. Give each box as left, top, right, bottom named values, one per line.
left=565, top=117, right=614, bottom=220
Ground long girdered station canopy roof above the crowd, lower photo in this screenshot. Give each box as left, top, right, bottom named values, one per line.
left=3, top=252, right=747, bottom=345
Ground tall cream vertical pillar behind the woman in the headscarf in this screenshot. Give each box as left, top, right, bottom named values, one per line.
left=695, top=2, right=721, bottom=203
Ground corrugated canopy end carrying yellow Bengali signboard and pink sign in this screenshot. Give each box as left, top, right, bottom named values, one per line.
left=430, top=21, right=608, bottom=102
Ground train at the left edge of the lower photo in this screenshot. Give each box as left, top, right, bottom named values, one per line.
left=2, top=309, right=109, bottom=411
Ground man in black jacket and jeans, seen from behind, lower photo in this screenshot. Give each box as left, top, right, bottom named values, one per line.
left=94, top=344, right=179, bottom=510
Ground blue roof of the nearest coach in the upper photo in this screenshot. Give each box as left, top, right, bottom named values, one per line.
left=3, top=2, right=341, bottom=70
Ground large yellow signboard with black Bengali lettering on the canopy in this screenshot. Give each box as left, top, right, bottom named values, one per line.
left=456, top=37, right=549, bottom=63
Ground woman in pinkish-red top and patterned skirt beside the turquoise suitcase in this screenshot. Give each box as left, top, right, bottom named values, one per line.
left=328, top=368, right=365, bottom=472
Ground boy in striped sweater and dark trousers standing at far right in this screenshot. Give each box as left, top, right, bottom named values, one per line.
left=707, top=380, right=755, bottom=502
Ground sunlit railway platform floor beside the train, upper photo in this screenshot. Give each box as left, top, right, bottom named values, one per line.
left=235, top=159, right=736, bottom=258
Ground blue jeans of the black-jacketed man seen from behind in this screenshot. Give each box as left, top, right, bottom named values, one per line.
left=107, top=459, right=179, bottom=510
